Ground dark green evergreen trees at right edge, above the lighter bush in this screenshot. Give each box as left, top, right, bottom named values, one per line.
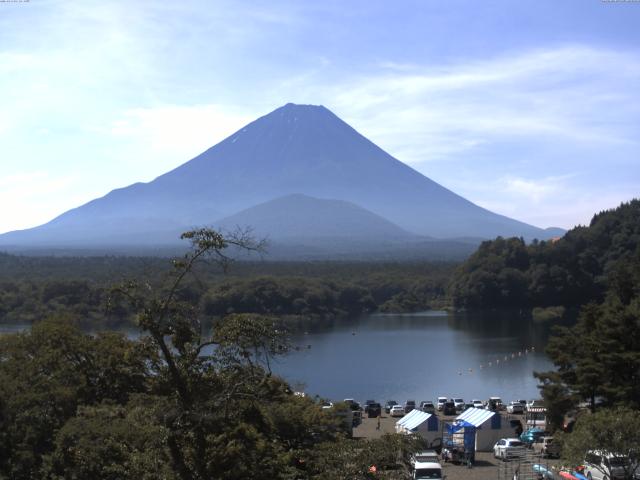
left=536, top=248, right=640, bottom=428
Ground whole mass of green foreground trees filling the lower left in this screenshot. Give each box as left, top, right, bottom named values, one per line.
left=0, top=230, right=424, bottom=480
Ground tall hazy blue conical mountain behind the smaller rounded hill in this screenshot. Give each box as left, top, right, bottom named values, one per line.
left=0, top=103, right=550, bottom=251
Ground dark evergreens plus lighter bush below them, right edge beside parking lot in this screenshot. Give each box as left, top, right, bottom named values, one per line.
left=535, top=220, right=640, bottom=462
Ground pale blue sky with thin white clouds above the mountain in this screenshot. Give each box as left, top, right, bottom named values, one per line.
left=0, top=0, right=640, bottom=232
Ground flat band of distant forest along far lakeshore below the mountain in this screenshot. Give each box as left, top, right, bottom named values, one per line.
left=0, top=254, right=455, bottom=328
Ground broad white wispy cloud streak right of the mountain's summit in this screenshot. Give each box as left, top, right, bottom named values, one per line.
left=318, top=45, right=640, bottom=163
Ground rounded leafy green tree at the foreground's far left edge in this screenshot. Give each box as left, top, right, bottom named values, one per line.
left=0, top=318, right=155, bottom=479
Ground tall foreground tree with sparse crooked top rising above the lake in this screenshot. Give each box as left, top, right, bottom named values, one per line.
left=108, top=230, right=368, bottom=480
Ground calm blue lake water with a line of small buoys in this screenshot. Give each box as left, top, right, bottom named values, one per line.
left=274, top=311, right=568, bottom=402
